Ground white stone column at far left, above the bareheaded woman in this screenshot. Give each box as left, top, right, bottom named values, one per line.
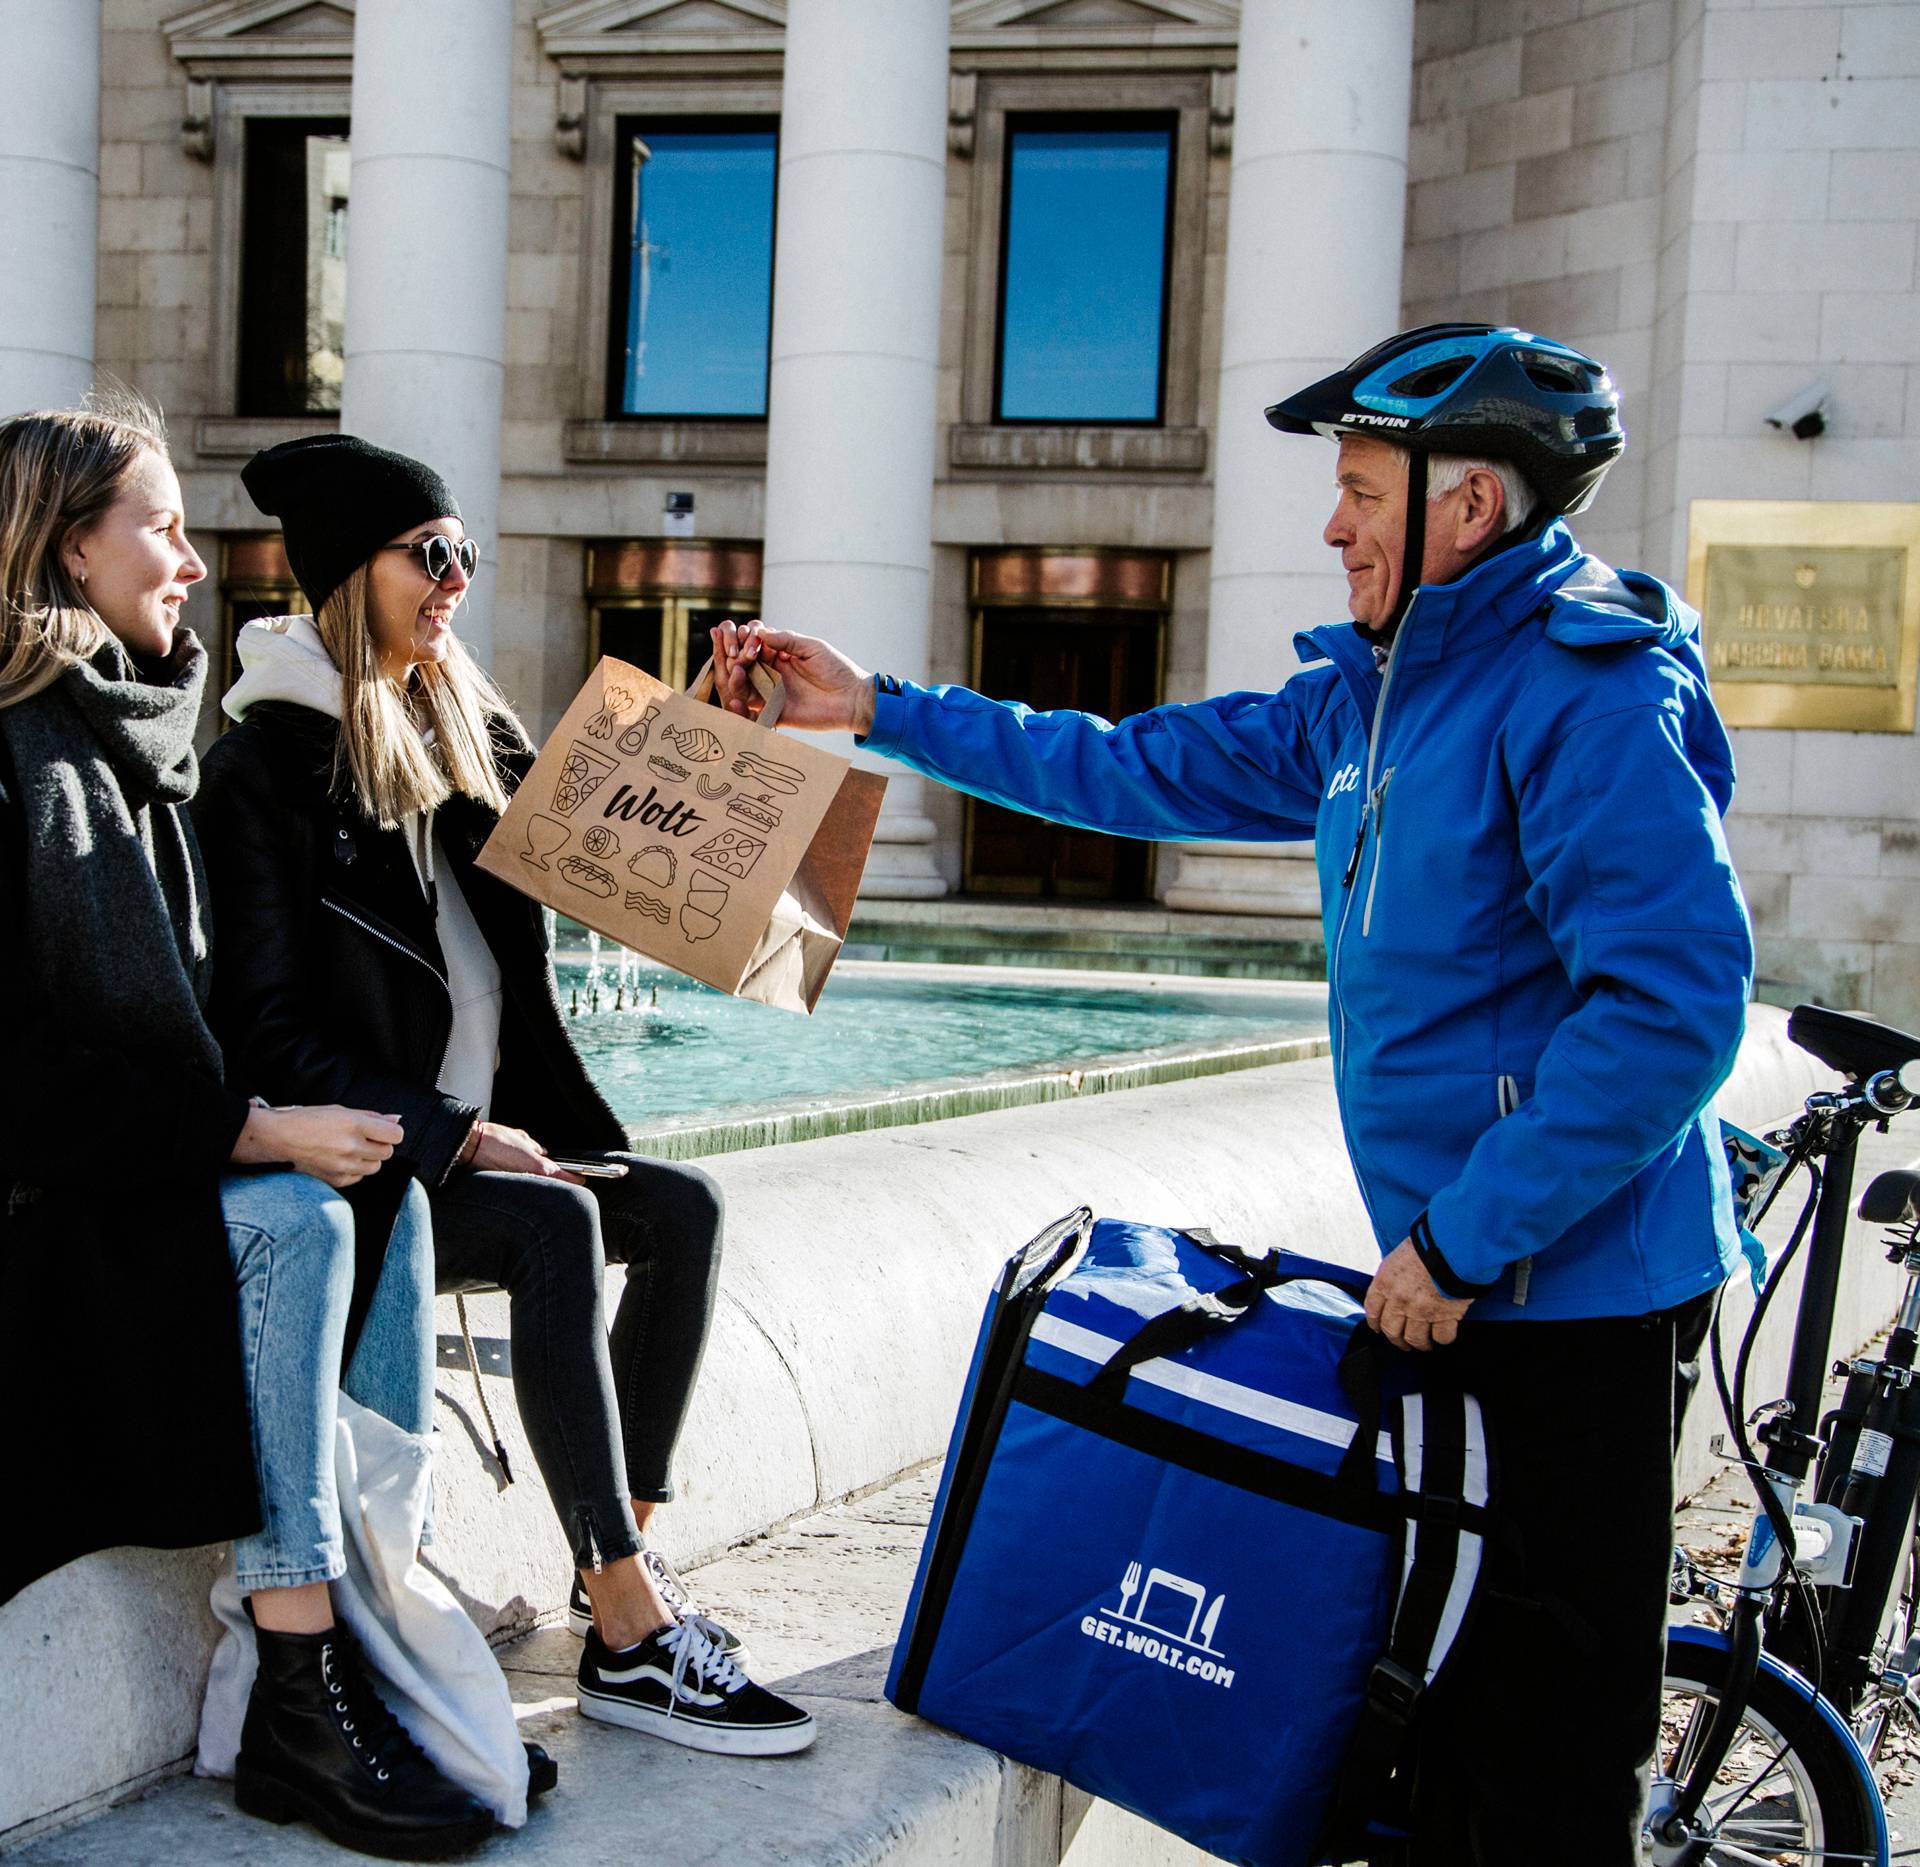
left=0, top=0, right=100, bottom=415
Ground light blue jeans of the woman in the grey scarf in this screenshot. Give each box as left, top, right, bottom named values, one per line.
left=221, top=1170, right=434, bottom=1594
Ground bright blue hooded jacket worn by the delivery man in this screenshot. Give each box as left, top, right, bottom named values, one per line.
left=866, top=522, right=1753, bottom=1320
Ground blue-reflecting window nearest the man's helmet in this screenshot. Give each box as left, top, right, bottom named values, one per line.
left=998, top=125, right=1173, bottom=421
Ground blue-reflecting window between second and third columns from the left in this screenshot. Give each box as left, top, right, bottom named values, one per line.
left=616, top=129, right=776, bottom=419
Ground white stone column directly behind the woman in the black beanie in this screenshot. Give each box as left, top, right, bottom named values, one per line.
left=340, top=0, right=513, bottom=663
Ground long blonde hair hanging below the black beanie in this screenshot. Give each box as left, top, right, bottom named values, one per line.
left=313, top=565, right=528, bottom=830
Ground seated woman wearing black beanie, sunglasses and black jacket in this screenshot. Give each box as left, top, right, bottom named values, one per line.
left=194, top=434, right=814, bottom=1756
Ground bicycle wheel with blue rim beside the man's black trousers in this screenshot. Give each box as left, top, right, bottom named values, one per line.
left=1644, top=1640, right=1887, bottom=1867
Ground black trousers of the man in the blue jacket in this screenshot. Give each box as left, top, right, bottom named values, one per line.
left=1409, top=1295, right=1713, bottom=1867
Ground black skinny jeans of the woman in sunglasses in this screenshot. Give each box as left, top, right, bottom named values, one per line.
left=430, top=1154, right=724, bottom=1569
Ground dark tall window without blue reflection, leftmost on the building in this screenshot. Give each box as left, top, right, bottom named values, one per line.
left=234, top=117, right=349, bottom=415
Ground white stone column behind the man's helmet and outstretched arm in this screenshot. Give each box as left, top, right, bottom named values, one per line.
left=1167, top=0, right=1413, bottom=914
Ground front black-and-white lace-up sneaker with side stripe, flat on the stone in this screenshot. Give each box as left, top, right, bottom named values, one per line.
left=580, top=1615, right=816, bottom=1758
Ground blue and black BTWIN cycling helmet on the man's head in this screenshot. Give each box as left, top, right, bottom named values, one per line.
left=1267, top=325, right=1626, bottom=517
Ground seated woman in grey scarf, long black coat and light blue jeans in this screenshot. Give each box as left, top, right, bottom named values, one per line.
left=0, top=401, right=492, bottom=1859
